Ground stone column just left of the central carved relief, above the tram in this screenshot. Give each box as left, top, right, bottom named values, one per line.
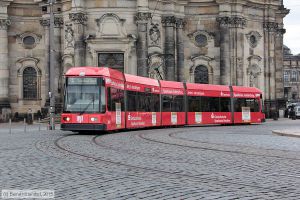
left=136, top=12, right=151, bottom=77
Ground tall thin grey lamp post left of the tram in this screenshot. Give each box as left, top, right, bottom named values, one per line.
left=48, top=0, right=55, bottom=130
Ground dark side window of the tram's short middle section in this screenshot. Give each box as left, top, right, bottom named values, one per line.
left=162, top=95, right=184, bottom=112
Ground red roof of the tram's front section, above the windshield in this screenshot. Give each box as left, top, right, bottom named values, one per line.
left=65, top=66, right=124, bottom=81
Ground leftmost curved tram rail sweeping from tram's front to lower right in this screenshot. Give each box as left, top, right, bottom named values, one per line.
left=50, top=135, right=296, bottom=195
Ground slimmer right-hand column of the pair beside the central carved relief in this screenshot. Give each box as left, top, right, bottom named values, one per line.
left=176, top=18, right=185, bottom=82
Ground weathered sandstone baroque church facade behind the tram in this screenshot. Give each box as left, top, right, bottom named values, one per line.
left=0, top=0, right=289, bottom=119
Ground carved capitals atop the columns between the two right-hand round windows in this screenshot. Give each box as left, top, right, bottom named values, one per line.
left=217, top=16, right=247, bottom=28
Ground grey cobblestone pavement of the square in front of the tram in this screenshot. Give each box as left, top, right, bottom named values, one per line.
left=0, top=120, right=300, bottom=199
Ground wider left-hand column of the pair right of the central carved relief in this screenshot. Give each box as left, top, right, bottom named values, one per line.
left=162, top=16, right=176, bottom=81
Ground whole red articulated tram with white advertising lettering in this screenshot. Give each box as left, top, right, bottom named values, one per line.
left=61, top=67, right=265, bottom=131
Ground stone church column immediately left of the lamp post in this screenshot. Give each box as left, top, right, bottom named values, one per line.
left=40, top=18, right=50, bottom=106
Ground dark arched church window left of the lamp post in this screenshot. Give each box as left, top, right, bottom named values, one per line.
left=23, top=67, right=37, bottom=99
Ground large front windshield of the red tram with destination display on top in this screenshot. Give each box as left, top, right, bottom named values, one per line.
left=64, top=77, right=104, bottom=114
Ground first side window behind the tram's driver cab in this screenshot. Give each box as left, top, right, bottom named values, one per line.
left=107, top=88, right=124, bottom=111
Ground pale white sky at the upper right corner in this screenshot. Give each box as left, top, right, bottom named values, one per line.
left=283, top=0, right=300, bottom=55
